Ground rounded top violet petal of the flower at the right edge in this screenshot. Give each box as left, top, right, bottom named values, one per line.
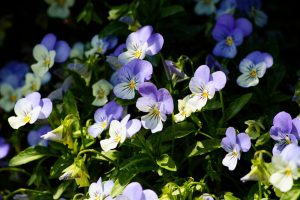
left=273, top=111, right=292, bottom=133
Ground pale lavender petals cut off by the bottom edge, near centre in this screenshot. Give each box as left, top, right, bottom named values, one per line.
left=115, top=182, right=158, bottom=200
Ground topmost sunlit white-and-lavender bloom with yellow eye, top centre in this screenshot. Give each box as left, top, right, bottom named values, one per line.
left=118, top=26, right=164, bottom=65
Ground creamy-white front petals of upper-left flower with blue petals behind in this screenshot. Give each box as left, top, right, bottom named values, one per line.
left=31, top=44, right=56, bottom=77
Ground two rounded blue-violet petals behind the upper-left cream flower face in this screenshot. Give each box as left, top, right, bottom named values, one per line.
left=41, top=33, right=71, bottom=63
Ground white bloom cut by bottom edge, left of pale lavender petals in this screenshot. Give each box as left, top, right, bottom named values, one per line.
left=89, top=177, right=114, bottom=200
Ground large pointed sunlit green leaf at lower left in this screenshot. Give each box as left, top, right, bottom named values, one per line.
left=9, top=146, right=53, bottom=167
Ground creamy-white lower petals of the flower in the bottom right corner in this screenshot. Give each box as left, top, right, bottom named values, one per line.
left=269, top=156, right=300, bottom=192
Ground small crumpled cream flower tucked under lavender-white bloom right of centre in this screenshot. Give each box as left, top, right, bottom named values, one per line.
left=174, top=95, right=193, bottom=123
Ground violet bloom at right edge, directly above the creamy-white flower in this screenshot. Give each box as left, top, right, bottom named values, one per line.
left=270, top=111, right=300, bottom=155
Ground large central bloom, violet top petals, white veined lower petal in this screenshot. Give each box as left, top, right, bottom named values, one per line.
left=136, top=82, right=174, bottom=133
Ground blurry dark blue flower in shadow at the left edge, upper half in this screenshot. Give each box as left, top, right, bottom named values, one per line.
left=0, top=61, right=29, bottom=88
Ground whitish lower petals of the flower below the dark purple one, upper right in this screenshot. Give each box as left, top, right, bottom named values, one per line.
left=236, top=58, right=267, bottom=88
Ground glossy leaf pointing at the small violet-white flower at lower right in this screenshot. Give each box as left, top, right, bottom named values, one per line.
left=187, top=139, right=221, bottom=157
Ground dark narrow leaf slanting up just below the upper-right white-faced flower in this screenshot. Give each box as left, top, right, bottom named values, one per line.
left=221, top=93, right=252, bottom=122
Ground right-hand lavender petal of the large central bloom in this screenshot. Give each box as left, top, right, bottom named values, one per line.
left=157, top=88, right=174, bottom=114
